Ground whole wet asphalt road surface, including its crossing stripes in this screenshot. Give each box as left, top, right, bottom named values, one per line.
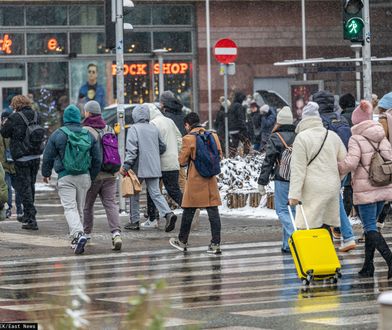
left=0, top=187, right=392, bottom=329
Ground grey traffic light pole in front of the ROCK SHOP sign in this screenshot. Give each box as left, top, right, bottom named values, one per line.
left=112, top=0, right=125, bottom=213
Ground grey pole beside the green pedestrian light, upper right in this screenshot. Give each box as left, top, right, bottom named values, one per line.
left=362, top=0, right=372, bottom=102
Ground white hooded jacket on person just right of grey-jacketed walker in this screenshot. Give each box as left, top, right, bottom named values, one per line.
left=148, top=103, right=182, bottom=172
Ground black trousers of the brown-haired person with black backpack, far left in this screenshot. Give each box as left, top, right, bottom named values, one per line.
left=15, top=158, right=40, bottom=222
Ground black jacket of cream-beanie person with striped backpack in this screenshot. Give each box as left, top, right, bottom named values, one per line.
left=257, top=125, right=295, bottom=186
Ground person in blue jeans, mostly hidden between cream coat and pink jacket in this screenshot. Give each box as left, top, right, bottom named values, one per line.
left=312, top=91, right=356, bottom=252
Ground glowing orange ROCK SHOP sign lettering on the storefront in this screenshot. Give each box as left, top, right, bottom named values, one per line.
left=112, top=62, right=189, bottom=76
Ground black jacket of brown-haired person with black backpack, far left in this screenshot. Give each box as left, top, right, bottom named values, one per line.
left=0, top=107, right=41, bottom=159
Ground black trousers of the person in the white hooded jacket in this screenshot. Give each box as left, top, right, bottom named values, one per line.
left=147, top=171, right=182, bottom=221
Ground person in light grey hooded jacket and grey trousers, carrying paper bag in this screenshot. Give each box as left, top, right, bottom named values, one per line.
left=120, top=104, right=177, bottom=232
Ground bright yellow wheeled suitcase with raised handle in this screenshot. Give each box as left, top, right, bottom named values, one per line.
left=289, top=204, right=341, bottom=285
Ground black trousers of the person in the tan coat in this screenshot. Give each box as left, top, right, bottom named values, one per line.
left=178, top=206, right=221, bottom=244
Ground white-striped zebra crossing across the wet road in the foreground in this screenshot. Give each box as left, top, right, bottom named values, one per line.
left=0, top=235, right=392, bottom=328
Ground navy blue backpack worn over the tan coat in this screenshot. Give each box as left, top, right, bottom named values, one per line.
left=190, top=131, right=221, bottom=178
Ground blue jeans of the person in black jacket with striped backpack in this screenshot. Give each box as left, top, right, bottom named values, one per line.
left=274, top=180, right=295, bottom=250
